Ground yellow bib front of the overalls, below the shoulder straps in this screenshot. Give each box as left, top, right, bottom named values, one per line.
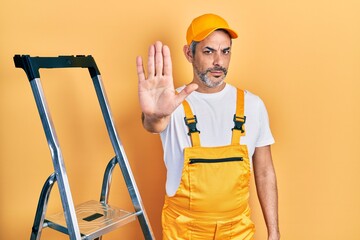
left=182, top=145, right=250, bottom=212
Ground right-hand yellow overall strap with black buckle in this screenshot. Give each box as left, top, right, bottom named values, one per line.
left=231, top=89, right=246, bottom=145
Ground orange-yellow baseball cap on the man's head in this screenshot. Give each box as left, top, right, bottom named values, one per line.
left=186, top=13, right=238, bottom=45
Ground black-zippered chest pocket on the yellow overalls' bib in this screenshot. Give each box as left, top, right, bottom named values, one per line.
left=188, top=157, right=247, bottom=212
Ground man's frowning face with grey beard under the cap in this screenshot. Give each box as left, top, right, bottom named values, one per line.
left=188, top=31, right=231, bottom=89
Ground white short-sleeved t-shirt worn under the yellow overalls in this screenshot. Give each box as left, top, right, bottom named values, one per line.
left=160, top=84, right=274, bottom=196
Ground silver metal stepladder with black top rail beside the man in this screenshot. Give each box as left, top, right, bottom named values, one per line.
left=14, top=55, right=154, bottom=240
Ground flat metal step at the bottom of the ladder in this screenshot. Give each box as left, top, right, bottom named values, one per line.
left=45, top=200, right=141, bottom=240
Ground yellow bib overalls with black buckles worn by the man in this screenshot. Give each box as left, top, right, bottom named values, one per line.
left=162, top=90, right=255, bottom=240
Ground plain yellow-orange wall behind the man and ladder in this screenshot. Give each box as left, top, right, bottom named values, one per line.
left=0, top=0, right=360, bottom=240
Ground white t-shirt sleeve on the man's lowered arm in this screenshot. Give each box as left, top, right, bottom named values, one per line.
left=255, top=98, right=275, bottom=147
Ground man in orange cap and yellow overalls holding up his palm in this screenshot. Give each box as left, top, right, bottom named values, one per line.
left=137, top=14, right=280, bottom=240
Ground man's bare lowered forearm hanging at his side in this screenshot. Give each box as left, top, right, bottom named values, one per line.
left=255, top=163, right=280, bottom=240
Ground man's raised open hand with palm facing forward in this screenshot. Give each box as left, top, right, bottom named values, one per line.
left=136, top=41, right=198, bottom=132
